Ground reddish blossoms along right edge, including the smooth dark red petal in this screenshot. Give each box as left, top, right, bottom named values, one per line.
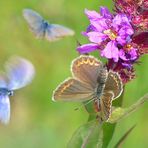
left=114, top=0, right=148, bottom=55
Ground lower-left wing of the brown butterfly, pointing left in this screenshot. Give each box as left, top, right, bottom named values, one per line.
left=52, top=78, right=93, bottom=101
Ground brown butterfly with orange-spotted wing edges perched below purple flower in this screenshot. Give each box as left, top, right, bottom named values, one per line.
left=52, top=55, right=123, bottom=121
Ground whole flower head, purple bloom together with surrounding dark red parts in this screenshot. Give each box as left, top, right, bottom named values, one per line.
left=77, top=0, right=148, bottom=83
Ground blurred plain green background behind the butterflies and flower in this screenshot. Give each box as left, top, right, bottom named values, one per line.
left=0, top=0, right=148, bottom=148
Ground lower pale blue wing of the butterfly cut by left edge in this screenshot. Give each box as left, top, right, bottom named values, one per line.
left=0, top=95, right=10, bottom=124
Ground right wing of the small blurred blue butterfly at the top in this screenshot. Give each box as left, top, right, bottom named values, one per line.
left=45, top=24, right=74, bottom=41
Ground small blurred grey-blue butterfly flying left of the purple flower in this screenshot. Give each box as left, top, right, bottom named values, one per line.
left=23, top=9, right=74, bottom=41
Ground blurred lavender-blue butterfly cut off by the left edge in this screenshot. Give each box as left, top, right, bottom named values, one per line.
left=0, top=57, right=35, bottom=124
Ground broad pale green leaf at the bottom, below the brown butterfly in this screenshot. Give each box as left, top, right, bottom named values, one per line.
left=67, top=120, right=103, bottom=148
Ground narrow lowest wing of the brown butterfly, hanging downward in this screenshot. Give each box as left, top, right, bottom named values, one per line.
left=99, top=91, right=114, bottom=121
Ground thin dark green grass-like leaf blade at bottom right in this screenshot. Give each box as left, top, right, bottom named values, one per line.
left=114, top=125, right=136, bottom=148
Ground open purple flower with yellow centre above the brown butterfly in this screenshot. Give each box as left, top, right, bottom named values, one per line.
left=77, top=7, right=136, bottom=62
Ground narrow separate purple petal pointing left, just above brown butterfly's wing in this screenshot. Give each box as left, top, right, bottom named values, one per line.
left=77, top=43, right=99, bottom=54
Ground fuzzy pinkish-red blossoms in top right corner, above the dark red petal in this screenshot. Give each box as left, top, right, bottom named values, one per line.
left=114, top=0, right=148, bottom=31
